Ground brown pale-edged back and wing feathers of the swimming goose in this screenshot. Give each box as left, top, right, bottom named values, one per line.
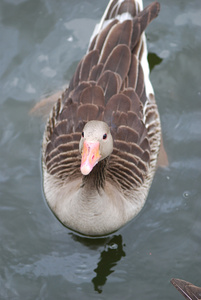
left=45, top=0, right=159, bottom=189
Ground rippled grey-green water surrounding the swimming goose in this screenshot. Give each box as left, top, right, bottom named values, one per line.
left=0, top=0, right=201, bottom=300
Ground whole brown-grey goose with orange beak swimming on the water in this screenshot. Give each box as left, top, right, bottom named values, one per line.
left=43, top=0, right=161, bottom=236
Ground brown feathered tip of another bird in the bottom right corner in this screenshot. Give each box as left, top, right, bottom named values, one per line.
left=170, top=278, right=201, bottom=300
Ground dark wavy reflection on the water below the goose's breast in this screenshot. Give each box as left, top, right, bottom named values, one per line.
left=71, top=233, right=126, bottom=293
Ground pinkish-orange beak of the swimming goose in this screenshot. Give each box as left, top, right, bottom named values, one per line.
left=80, top=141, right=101, bottom=175
